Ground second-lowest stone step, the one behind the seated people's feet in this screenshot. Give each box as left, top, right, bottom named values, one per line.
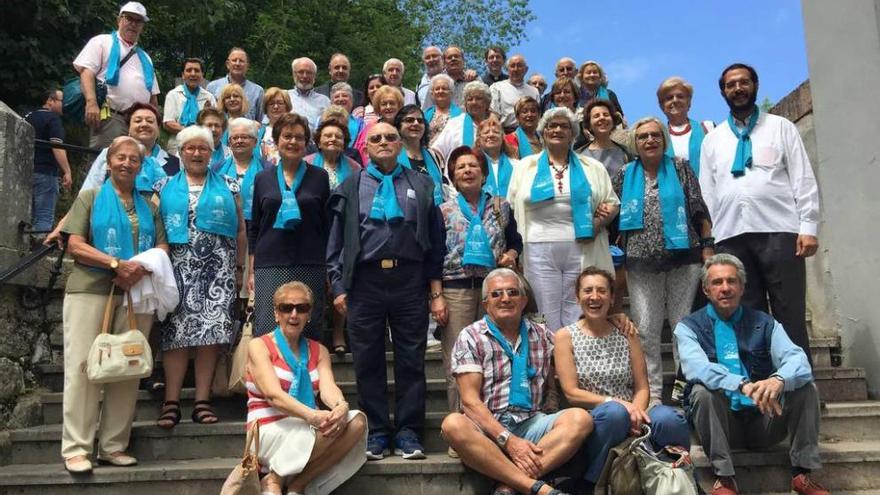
left=6, top=401, right=880, bottom=464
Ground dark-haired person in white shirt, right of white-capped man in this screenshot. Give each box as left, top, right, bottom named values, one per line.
left=162, top=58, right=217, bottom=156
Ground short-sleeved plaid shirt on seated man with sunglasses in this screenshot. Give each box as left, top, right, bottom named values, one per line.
left=452, top=319, right=553, bottom=423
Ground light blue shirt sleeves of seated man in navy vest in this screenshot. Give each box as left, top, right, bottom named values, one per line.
left=674, top=304, right=813, bottom=392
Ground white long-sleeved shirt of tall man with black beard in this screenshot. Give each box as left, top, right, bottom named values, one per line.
left=700, top=112, right=819, bottom=241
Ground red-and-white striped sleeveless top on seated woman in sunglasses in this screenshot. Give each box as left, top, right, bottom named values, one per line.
left=245, top=332, right=321, bottom=428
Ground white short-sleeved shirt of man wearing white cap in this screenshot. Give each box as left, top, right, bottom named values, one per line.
left=73, top=34, right=159, bottom=112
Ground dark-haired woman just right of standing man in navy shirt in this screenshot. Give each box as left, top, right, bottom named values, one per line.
left=394, top=105, right=446, bottom=205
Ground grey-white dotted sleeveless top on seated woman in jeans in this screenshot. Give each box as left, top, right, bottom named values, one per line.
left=568, top=323, right=634, bottom=401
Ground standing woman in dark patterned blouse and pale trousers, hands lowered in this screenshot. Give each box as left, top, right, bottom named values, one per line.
left=612, top=117, right=714, bottom=401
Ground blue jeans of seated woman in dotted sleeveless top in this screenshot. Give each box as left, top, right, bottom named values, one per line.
left=581, top=402, right=691, bottom=483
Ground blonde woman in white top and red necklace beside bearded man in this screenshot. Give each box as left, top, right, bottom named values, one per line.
left=657, top=76, right=715, bottom=178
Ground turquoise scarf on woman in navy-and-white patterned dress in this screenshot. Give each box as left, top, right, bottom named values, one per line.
left=159, top=169, right=238, bottom=244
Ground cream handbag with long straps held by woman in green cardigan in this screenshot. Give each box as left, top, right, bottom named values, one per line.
left=86, top=284, right=153, bottom=383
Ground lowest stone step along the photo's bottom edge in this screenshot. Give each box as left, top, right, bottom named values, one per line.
left=0, top=442, right=880, bottom=495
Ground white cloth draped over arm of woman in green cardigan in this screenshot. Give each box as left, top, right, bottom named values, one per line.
left=129, top=248, right=180, bottom=320
